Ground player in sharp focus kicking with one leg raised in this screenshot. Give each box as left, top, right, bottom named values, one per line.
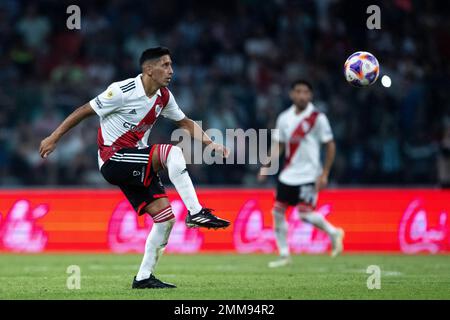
left=39, top=47, right=230, bottom=288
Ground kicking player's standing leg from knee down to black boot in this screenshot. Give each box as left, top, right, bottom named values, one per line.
left=132, top=199, right=176, bottom=289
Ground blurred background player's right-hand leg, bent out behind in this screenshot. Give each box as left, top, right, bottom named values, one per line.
left=299, top=206, right=345, bottom=258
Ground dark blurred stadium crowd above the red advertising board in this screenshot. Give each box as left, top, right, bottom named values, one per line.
left=0, top=0, right=450, bottom=187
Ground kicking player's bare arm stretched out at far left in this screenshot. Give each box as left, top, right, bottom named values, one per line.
left=39, top=103, right=95, bottom=158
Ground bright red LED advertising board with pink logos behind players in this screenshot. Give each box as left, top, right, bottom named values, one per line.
left=0, top=189, right=450, bottom=254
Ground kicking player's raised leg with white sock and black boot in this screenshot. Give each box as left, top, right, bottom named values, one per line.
left=158, top=144, right=230, bottom=229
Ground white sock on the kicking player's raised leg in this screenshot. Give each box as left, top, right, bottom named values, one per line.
left=165, top=146, right=202, bottom=214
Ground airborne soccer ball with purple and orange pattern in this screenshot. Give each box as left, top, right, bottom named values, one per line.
left=344, top=51, right=380, bottom=87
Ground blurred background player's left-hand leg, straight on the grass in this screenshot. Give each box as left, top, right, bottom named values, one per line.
left=269, top=201, right=291, bottom=268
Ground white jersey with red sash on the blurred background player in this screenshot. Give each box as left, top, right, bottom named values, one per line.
left=272, top=103, right=333, bottom=186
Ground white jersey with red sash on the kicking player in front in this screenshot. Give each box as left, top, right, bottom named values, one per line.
left=89, top=74, right=185, bottom=168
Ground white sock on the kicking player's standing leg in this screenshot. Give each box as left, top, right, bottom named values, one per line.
left=136, top=219, right=175, bottom=281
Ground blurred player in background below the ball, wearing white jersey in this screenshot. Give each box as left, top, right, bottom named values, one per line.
left=258, top=80, right=344, bottom=268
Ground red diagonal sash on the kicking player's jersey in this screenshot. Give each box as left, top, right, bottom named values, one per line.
left=97, top=88, right=169, bottom=161
